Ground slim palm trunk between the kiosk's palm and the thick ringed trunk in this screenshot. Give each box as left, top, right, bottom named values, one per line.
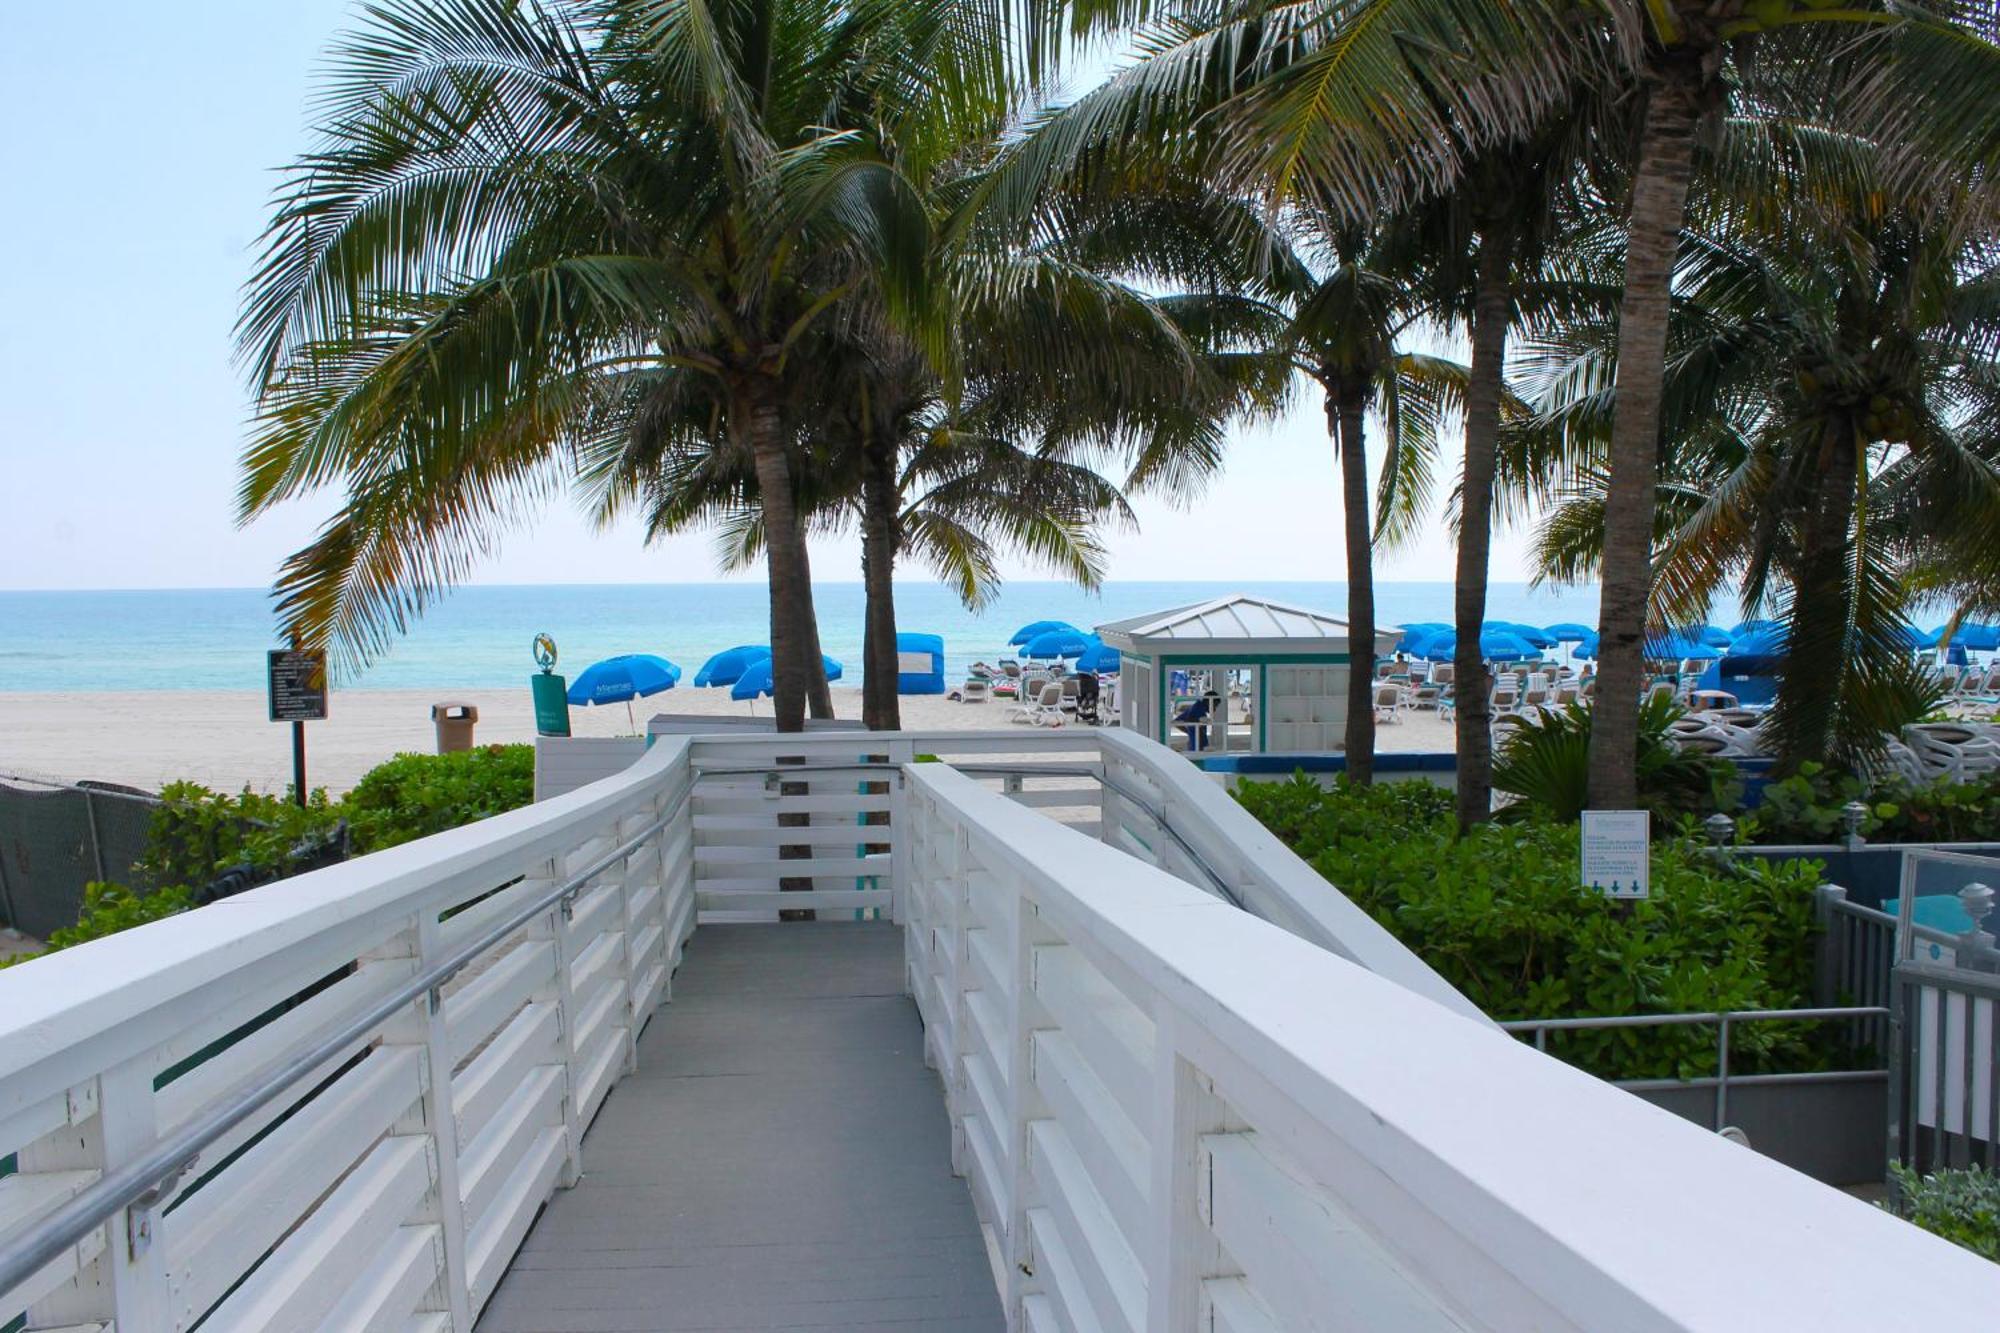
left=1452, top=226, right=1514, bottom=829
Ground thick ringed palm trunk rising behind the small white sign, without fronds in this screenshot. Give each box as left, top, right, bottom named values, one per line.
left=1590, top=67, right=1702, bottom=811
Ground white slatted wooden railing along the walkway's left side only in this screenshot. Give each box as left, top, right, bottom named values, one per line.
left=0, top=741, right=694, bottom=1333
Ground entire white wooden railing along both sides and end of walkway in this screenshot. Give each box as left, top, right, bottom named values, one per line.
left=0, top=729, right=1996, bottom=1333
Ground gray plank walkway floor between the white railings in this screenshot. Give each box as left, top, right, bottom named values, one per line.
left=480, top=923, right=1004, bottom=1333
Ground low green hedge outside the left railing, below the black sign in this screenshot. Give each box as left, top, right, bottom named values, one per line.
left=0, top=745, right=534, bottom=967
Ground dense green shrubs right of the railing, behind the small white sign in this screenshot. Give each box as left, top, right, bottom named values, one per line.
left=1236, top=777, right=1826, bottom=1079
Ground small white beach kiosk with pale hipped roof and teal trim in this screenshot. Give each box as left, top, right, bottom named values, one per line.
left=1098, top=592, right=1400, bottom=755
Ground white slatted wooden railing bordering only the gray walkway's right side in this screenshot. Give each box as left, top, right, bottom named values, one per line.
left=898, top=765, right=2000, bottom=1333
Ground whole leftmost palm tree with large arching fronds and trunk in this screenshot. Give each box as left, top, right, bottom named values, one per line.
left=240, top=0, right=1014, bottom=731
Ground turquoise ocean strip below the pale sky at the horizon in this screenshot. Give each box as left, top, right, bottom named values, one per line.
left=0, top=582, right=1598, bottom=693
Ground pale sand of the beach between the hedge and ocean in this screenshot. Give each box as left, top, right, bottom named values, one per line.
left=0, top=687, right=1452, bottom=793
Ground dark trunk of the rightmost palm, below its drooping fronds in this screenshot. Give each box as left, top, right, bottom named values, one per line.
left=1770, top=418, right=1860, bottom=773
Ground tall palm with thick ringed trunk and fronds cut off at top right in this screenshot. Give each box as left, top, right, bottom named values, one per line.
left=1016, top=0, right=2000, bottom=807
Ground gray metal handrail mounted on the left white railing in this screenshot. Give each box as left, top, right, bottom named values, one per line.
left=0, top=785, right=692, bottom=1291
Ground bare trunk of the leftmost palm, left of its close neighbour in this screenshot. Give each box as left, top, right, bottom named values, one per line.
left=730, top=380, right=818, bottom=731
